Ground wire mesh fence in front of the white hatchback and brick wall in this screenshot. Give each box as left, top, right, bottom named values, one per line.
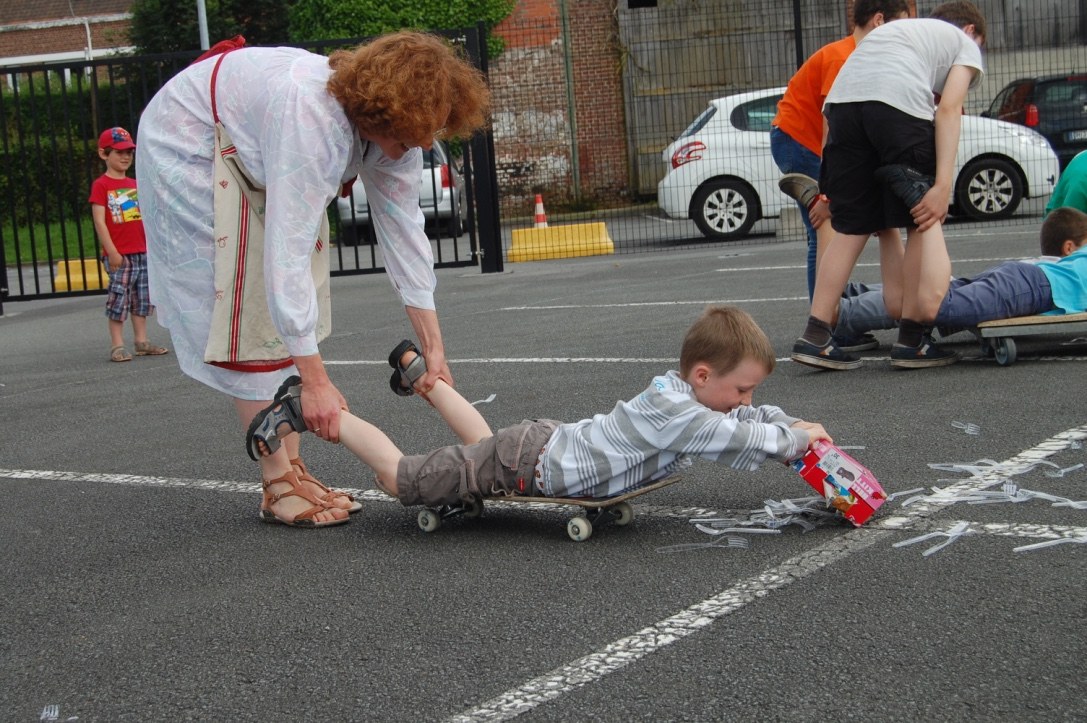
left=491, top=0, right=1087, bottom=253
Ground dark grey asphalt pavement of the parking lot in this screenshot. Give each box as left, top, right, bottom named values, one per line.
left=0, top=217, right=1087, bottom=723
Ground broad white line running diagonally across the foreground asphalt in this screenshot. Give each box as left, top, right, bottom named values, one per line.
left=449, top=425, right=1087, bottom=723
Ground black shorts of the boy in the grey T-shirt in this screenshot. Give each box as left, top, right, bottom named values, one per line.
left=820, top=101, right=936, bottom=235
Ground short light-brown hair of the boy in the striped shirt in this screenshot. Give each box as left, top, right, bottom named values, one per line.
left=679, top=307, right=777, bottom=377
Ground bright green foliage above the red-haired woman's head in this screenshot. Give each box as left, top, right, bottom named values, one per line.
left=290, top=0, right=516, bottom=57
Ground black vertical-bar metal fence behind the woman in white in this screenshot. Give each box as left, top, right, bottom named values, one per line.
left=0, top=28, right=500, bottom=312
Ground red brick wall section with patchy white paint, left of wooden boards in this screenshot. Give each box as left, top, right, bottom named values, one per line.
left=490, top=0, right=628, bottom=213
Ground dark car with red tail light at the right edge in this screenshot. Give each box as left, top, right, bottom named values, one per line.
left=982, top=73, right=1087, bottom=171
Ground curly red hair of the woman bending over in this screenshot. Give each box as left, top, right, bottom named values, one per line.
left=328, top=30, right=490, bottom=146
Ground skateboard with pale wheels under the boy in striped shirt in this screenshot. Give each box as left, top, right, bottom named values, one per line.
left=417, top=475, right=682, bottom=543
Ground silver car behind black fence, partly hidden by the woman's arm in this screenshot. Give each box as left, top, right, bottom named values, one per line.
left=336, top=140, right=467, bottom=245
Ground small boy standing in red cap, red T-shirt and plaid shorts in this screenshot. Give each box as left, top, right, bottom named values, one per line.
left=90, top=126, right=168, bottom=362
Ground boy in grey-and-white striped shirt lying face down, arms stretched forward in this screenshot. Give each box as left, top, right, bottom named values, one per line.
left=246, top=307, right=833, bottom=507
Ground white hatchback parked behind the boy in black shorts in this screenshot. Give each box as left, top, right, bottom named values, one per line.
left=657, top=88, right=1060, bottom=240
